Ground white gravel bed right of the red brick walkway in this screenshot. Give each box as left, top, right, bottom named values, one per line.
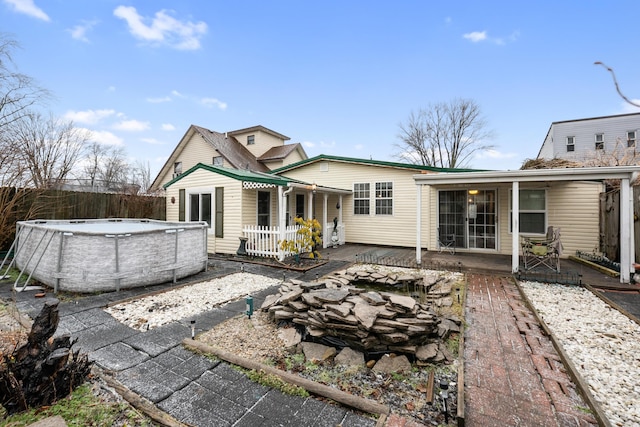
left=521, top=282, right=640, bottom=427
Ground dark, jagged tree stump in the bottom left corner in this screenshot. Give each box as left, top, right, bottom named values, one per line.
left=0, top=300, right=93, bottom=414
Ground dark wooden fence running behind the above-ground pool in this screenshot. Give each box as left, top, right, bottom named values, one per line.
left=0, top=187, right=166, bottom=250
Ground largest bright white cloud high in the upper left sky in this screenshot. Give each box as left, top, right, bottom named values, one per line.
left=113, top=6, right=207, bottom=50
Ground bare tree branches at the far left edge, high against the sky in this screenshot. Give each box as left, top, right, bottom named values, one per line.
left=0, top=33, right=51, bottom=129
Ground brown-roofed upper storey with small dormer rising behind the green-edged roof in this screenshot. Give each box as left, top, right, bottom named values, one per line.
left=149, top=125, right=307, bottom=193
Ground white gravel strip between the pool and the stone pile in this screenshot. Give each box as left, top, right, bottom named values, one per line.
left=105, top=273, right=280, bottom=331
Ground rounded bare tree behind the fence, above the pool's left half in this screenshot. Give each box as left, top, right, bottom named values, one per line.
left=9, top=112, right=90, bottom=188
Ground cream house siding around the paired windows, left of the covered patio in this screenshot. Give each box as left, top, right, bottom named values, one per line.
left=283, top=161, right=428, bottom=247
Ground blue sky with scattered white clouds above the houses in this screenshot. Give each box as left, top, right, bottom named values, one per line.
left=0, top=0, right=640, bottom=176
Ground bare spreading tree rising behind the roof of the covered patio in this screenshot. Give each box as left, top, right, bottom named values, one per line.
left=395, top=99, right=493, bottom=168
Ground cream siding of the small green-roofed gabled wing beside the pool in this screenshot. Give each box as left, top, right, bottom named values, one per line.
left=166, top=170, right=244, bottom=253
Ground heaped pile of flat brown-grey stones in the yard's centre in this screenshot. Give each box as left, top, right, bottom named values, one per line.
left=261, top=272, right=459, bottom=362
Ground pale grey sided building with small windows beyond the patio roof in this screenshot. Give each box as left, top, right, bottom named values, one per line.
left=538, top=113, right=640, bottom=162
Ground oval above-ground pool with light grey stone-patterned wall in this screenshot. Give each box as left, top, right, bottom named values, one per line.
left=14, top=219, right=208, bottom=292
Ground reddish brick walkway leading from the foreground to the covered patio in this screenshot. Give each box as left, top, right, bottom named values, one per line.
left=464, top=274, right=598, bottom=427
